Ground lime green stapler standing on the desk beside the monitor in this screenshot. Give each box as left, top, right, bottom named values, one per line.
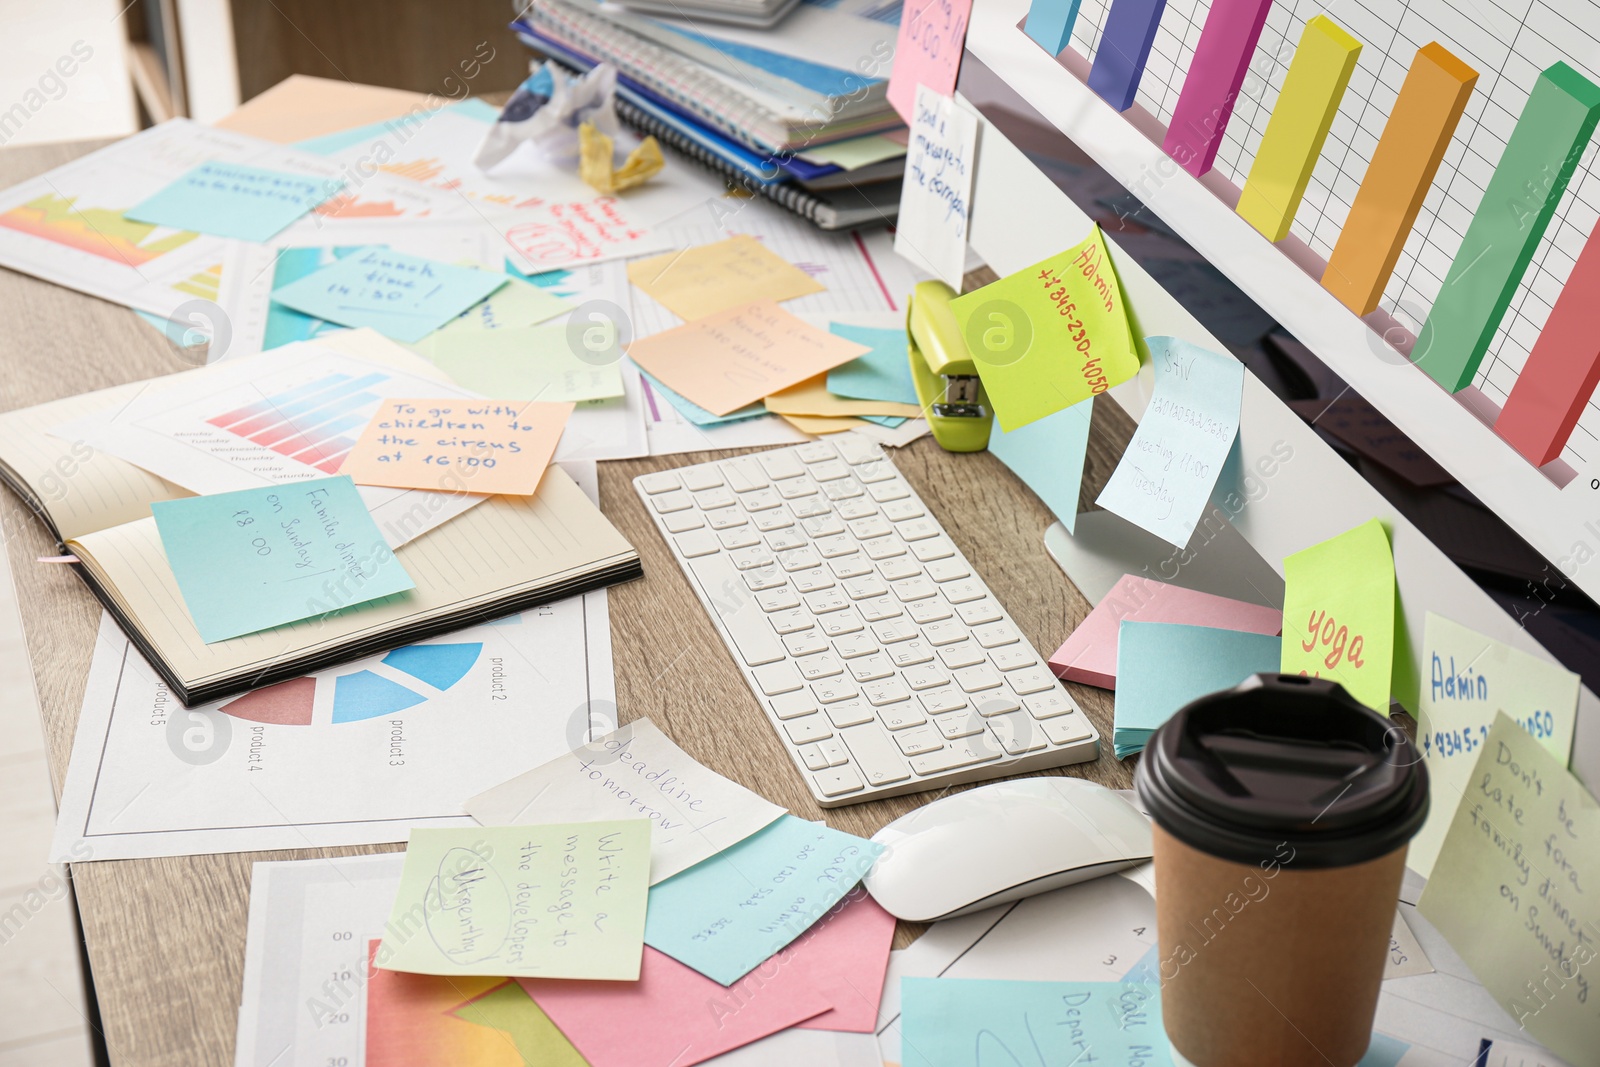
left=906, top=282, right=994, bottom=453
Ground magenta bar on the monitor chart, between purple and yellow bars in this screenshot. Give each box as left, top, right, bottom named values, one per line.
left=1162, top=0, right=1272, bottom=178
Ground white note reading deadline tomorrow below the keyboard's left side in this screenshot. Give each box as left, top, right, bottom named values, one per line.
left=462, top=718, right=784, bottom=885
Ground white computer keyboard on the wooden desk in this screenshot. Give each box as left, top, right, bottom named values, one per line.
left=634, top=432, right=1099, bottom=808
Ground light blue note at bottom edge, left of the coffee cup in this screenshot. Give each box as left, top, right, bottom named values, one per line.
left=901, top=977, right=1173, bottom=1067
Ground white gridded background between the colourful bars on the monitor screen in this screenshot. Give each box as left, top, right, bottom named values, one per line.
left=1072, top=0, right=1600, bottom=482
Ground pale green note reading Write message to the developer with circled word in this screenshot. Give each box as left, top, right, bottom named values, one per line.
left=378, top=819, right=650, bottom=982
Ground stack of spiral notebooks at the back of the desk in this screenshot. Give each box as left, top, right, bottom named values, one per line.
left=512, top=0, right=906, bottom=230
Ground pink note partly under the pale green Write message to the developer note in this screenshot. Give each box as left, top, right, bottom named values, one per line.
left=517, top=945, right=832, bottom=1067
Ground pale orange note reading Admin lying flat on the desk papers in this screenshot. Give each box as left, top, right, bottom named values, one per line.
left=627, top=234, right=824, bottom=320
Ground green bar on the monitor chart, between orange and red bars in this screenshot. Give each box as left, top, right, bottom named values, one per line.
left=1411, top=62, right=1600, bottom=392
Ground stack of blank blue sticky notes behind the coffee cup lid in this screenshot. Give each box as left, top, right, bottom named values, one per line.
left=1114, top=621, right=1282, bottom=760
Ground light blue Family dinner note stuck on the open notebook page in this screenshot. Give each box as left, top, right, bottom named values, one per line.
left=150, top=475, right=416, bottom=645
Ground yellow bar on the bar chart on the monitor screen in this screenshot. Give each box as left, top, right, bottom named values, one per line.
left=1235, top=14, right=1362, bottom=242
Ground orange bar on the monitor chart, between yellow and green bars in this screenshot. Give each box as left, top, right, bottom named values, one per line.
left=1322, top=42, right=1478, bottom=315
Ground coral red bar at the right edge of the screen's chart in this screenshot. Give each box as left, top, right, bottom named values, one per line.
left=1494, top=222, right=1600, bottom=467
